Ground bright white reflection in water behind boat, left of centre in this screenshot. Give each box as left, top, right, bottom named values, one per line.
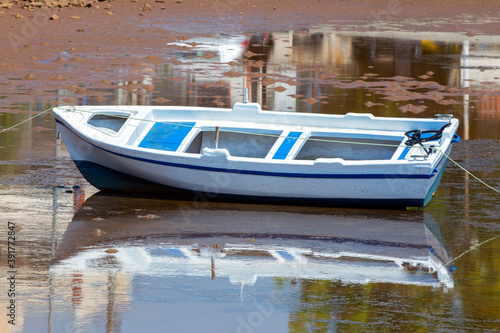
left=164, top=36, right=249, bottom=107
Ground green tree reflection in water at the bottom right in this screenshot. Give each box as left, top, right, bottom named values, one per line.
left=282, top=279, right=461, bottom=332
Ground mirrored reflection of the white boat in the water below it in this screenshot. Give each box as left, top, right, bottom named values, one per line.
left=52, top=195, right=453, bottom=288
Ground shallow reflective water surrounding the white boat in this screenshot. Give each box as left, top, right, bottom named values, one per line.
left=0, top=27, right=500, bottom=332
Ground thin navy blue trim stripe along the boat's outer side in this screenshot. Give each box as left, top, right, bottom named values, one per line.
left=56, top=119, right=434, bottom=179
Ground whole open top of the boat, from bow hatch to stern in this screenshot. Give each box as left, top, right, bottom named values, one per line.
left=75, top=103, right=458, bottom=162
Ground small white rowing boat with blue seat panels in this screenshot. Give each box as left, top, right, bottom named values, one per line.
left=54, top=103, right=459, bottom=207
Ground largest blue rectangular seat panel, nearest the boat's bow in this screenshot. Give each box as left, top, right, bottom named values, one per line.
left=139, top=122, right=196, bottom=151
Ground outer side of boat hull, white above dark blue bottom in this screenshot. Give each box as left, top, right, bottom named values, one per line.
left=60, top=120, right=446, bottom=207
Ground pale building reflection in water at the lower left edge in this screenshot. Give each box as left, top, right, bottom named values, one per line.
left=0, top=185, right=94, bottom=332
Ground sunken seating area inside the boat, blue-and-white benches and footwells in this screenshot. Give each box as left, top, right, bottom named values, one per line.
left=131, top=121, right=428, bottom=160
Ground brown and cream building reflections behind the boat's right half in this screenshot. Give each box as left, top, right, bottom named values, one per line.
left=262, top=28, right=500, bottom=135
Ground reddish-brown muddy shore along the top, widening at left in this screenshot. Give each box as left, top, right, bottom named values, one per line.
left=0, top=0, right=500, bottom=108
